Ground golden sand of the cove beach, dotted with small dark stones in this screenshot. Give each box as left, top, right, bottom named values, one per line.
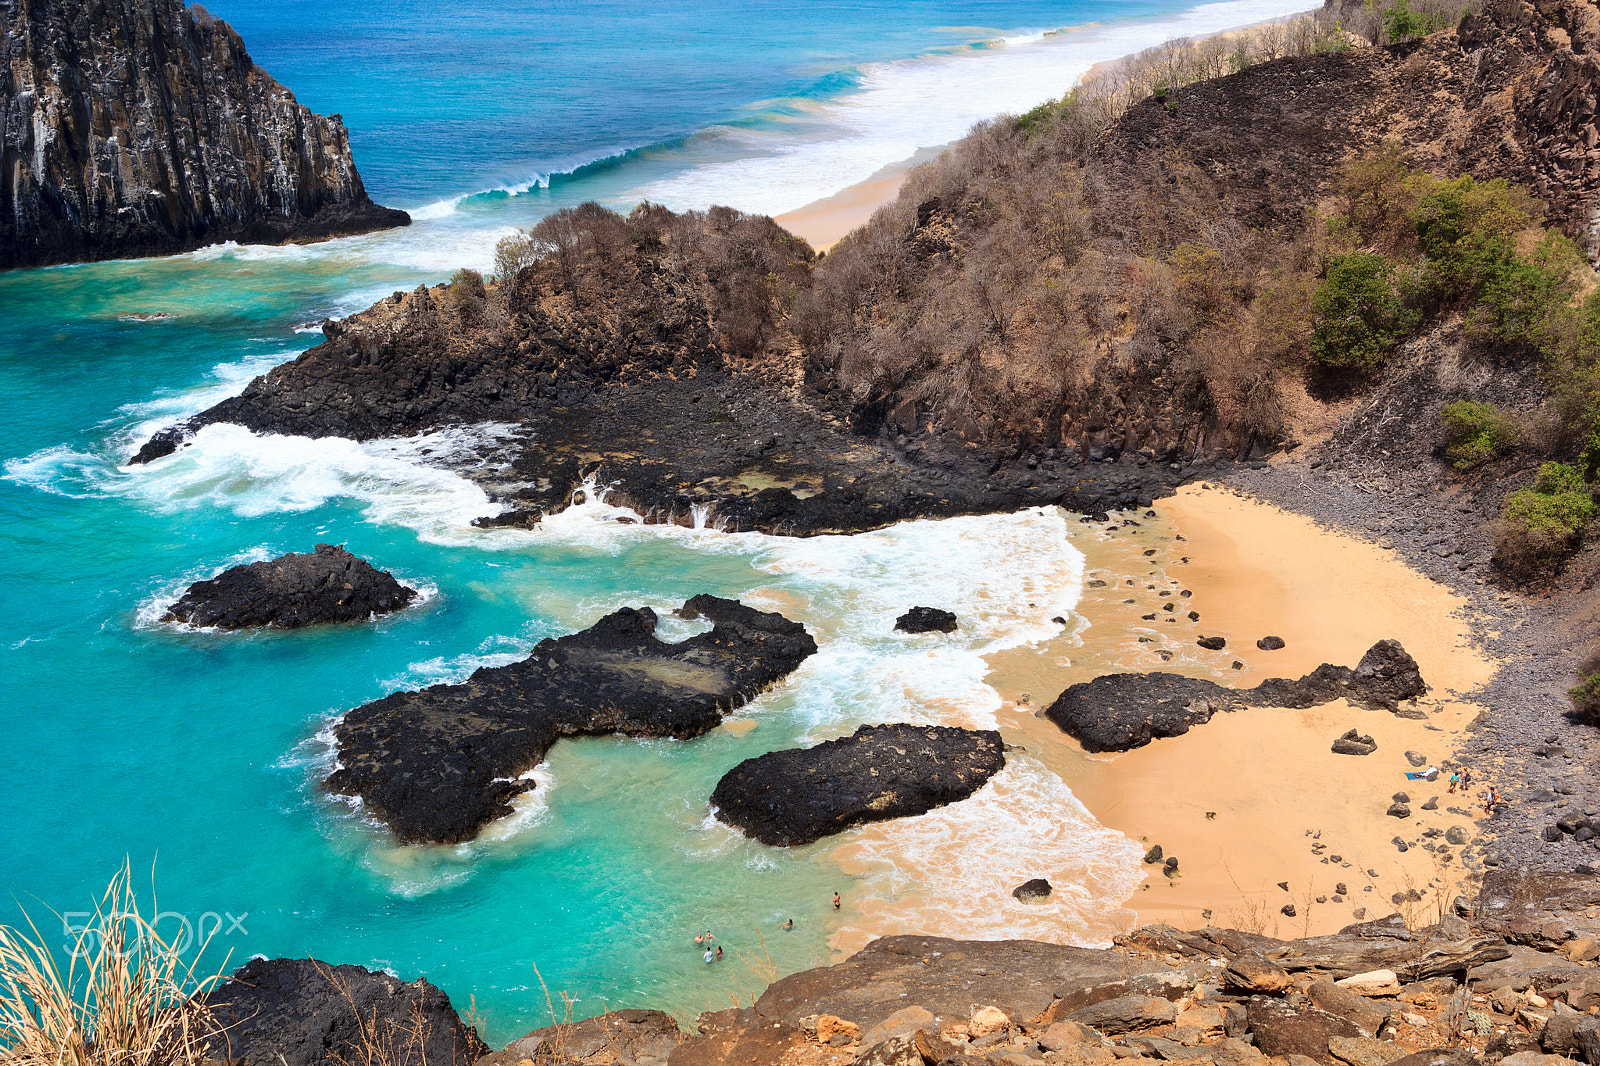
left=989, top=487, right=1493, bottom=936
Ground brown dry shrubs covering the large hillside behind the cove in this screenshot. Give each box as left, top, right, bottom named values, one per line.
left=792, top=3, right=1464, bottom=455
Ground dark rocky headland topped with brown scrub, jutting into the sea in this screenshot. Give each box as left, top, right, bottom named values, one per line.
left=133, top=208, right=1211, bottom=535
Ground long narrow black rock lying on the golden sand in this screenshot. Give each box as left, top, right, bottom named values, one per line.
left=1043, top=640, right=1427, bottom=751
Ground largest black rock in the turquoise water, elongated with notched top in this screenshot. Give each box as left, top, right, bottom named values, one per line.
left=325, top=595, right=816, bottom=844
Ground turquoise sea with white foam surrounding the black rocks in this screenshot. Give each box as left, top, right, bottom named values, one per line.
left=0, top=0, right=1301, bottom=1042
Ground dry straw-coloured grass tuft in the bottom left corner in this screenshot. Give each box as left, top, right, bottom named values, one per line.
left=0, top=863, right=226, bottom=1066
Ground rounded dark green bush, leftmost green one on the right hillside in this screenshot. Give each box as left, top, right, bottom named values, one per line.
left=1310, top=251, right=1414, bottom=371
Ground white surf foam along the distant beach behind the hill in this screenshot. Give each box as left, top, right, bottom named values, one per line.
left=632, top=0, right=1315, bottom=214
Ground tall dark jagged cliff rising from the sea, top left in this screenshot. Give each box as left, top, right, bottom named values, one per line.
left=0, top=0, right=411, bottom=269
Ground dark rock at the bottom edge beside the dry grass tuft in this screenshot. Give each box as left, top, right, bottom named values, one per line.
left=205, top=959, right=490, bottom=1066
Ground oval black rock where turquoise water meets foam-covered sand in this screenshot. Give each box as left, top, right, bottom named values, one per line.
left=710, top=725, right=1005, bottom=847
